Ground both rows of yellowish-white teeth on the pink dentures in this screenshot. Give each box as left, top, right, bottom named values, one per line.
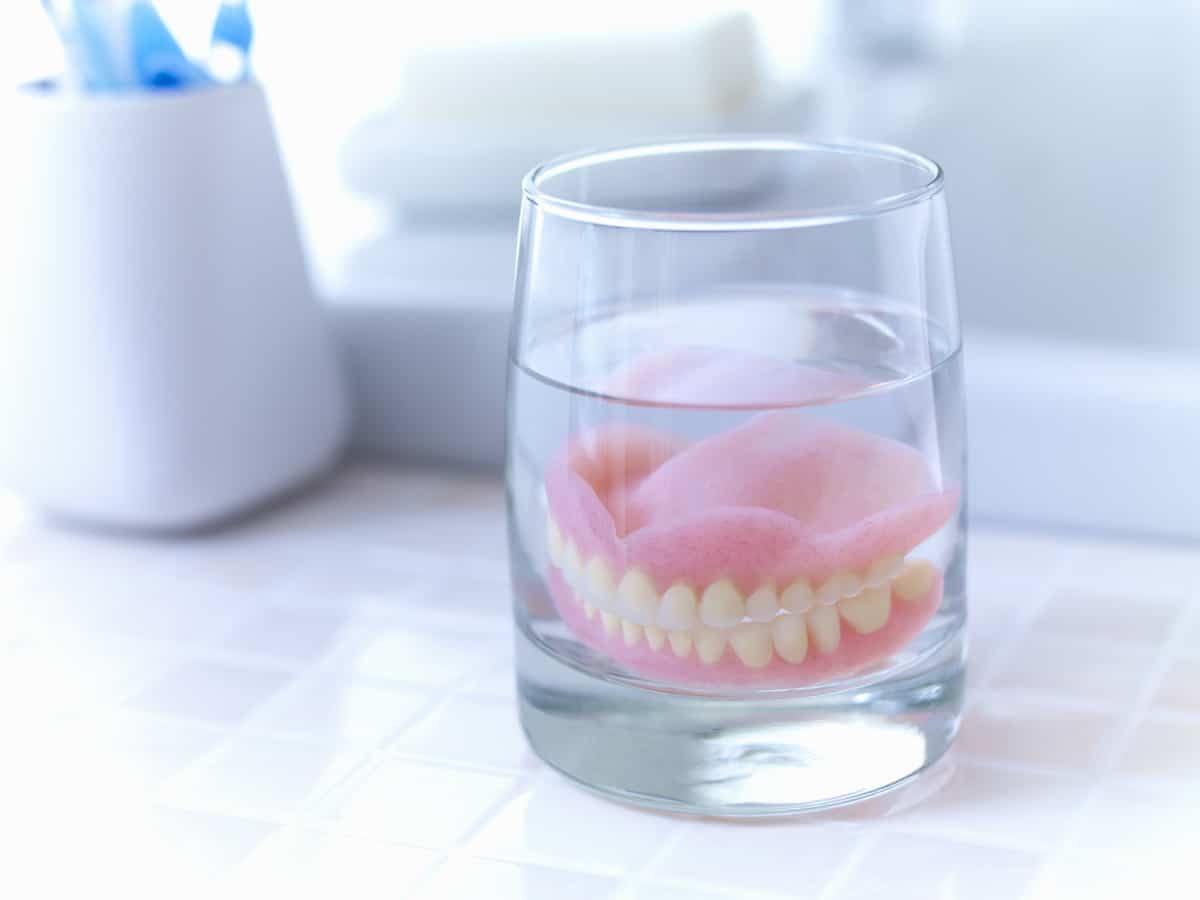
left=546, top=518, right=937, bottom=668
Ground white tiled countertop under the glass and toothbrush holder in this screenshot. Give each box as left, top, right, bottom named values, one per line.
left=0, top=464, right=1200, bottom=900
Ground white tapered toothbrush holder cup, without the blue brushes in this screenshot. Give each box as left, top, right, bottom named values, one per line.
left=0, top=83, right=350, bottom=530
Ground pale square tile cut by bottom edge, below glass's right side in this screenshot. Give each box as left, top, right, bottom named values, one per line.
left=833, top=834, right=1042, bottom=900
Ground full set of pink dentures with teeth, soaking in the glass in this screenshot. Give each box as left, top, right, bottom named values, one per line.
left=546, top=349, right=958, bottom=686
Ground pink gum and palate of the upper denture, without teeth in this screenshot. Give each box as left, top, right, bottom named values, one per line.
left=546, top=410, right=956, bottom=595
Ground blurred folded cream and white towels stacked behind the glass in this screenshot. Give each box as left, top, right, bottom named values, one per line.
left=341, top=12, right=796, bottom=211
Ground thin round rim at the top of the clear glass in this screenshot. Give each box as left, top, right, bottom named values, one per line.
left=521, top=134, right=944, bottom=232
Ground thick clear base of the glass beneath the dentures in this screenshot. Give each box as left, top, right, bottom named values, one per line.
left=517, top=629, right=964, bottom=817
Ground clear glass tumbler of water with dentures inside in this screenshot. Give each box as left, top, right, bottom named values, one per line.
left=508, top=138, right=965, bottom=816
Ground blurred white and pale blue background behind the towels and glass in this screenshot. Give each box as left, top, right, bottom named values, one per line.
left=9, top=0, right=1200, bottom=352
